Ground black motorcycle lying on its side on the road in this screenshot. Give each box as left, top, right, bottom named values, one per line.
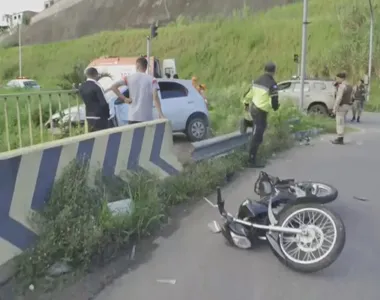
left=205, top=172, right=346, bottom=273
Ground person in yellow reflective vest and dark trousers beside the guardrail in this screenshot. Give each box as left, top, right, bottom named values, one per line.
left=248, top=62, right=279, bottom=168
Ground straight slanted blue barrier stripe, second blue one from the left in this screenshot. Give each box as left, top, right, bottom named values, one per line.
left=31, top=146, right=62, bottom=211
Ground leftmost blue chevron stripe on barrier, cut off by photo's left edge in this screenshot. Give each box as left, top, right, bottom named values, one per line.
left=0, top=156, right=36, bottom=250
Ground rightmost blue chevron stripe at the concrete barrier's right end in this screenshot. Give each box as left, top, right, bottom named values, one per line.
left=150, top=123, right=179, bottom=175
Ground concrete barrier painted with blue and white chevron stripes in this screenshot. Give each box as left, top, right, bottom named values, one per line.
left=0, top=120, right=182, bottom=272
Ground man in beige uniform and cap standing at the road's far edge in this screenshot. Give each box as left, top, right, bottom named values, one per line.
left=331, top=73, right=352, bottom=145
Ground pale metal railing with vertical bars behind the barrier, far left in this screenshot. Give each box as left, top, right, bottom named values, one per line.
left=0, top=90, right=87, bottom=152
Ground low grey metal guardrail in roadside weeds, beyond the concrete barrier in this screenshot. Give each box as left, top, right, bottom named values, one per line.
left=192, top=118, right=322, bottom=162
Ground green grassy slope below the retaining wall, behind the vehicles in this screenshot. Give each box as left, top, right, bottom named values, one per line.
left=0, top=0, right=380, bottom=149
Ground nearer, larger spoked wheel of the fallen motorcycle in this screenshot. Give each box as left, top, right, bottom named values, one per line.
left=271, top=203, right=346, bottom=273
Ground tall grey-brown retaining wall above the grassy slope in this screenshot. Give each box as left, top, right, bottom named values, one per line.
left=3, top=0, right=299, bottom=45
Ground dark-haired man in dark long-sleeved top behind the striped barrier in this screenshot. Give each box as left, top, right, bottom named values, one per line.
left=79, top=68, right=110, bottom=132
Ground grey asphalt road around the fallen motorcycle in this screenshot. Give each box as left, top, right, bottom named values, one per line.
left=95, top=114, right=380, bottom=300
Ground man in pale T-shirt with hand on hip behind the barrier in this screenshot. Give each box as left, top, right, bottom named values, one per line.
left=110, top=57, right=165, bottom=124
